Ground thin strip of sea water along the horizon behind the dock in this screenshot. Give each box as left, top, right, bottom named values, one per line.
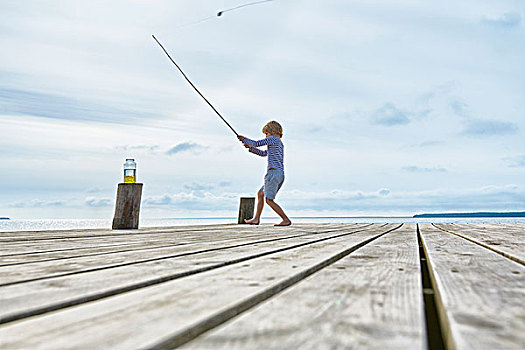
left=0, top=217, right=525, bottom=232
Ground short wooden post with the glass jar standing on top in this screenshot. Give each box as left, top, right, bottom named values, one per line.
left=113, top=183, right=142, bottom=230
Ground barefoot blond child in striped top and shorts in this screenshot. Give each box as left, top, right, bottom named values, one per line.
left=237, top=120, right=292, bottom=226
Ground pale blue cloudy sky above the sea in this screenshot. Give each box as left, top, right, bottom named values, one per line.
left=0, top=0, right=525, bottom=219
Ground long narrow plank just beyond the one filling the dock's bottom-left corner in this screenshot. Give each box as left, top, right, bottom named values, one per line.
left=0, top=225, right=383, bottom=319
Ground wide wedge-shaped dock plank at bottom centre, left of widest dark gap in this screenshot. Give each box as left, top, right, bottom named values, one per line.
left=182, top=224, right=426, bottom=349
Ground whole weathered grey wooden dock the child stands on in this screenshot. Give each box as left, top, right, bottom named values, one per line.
left=0, top=223, right=525, bottom=350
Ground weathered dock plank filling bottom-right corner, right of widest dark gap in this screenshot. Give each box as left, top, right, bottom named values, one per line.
left=420, top=224, right=525, bottom=350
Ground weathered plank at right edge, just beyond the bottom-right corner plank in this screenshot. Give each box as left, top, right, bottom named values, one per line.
left=434, top=224, right=525, bottom=265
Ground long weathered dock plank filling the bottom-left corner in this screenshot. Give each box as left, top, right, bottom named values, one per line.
left=0, top=226, right=391, bottom=349
